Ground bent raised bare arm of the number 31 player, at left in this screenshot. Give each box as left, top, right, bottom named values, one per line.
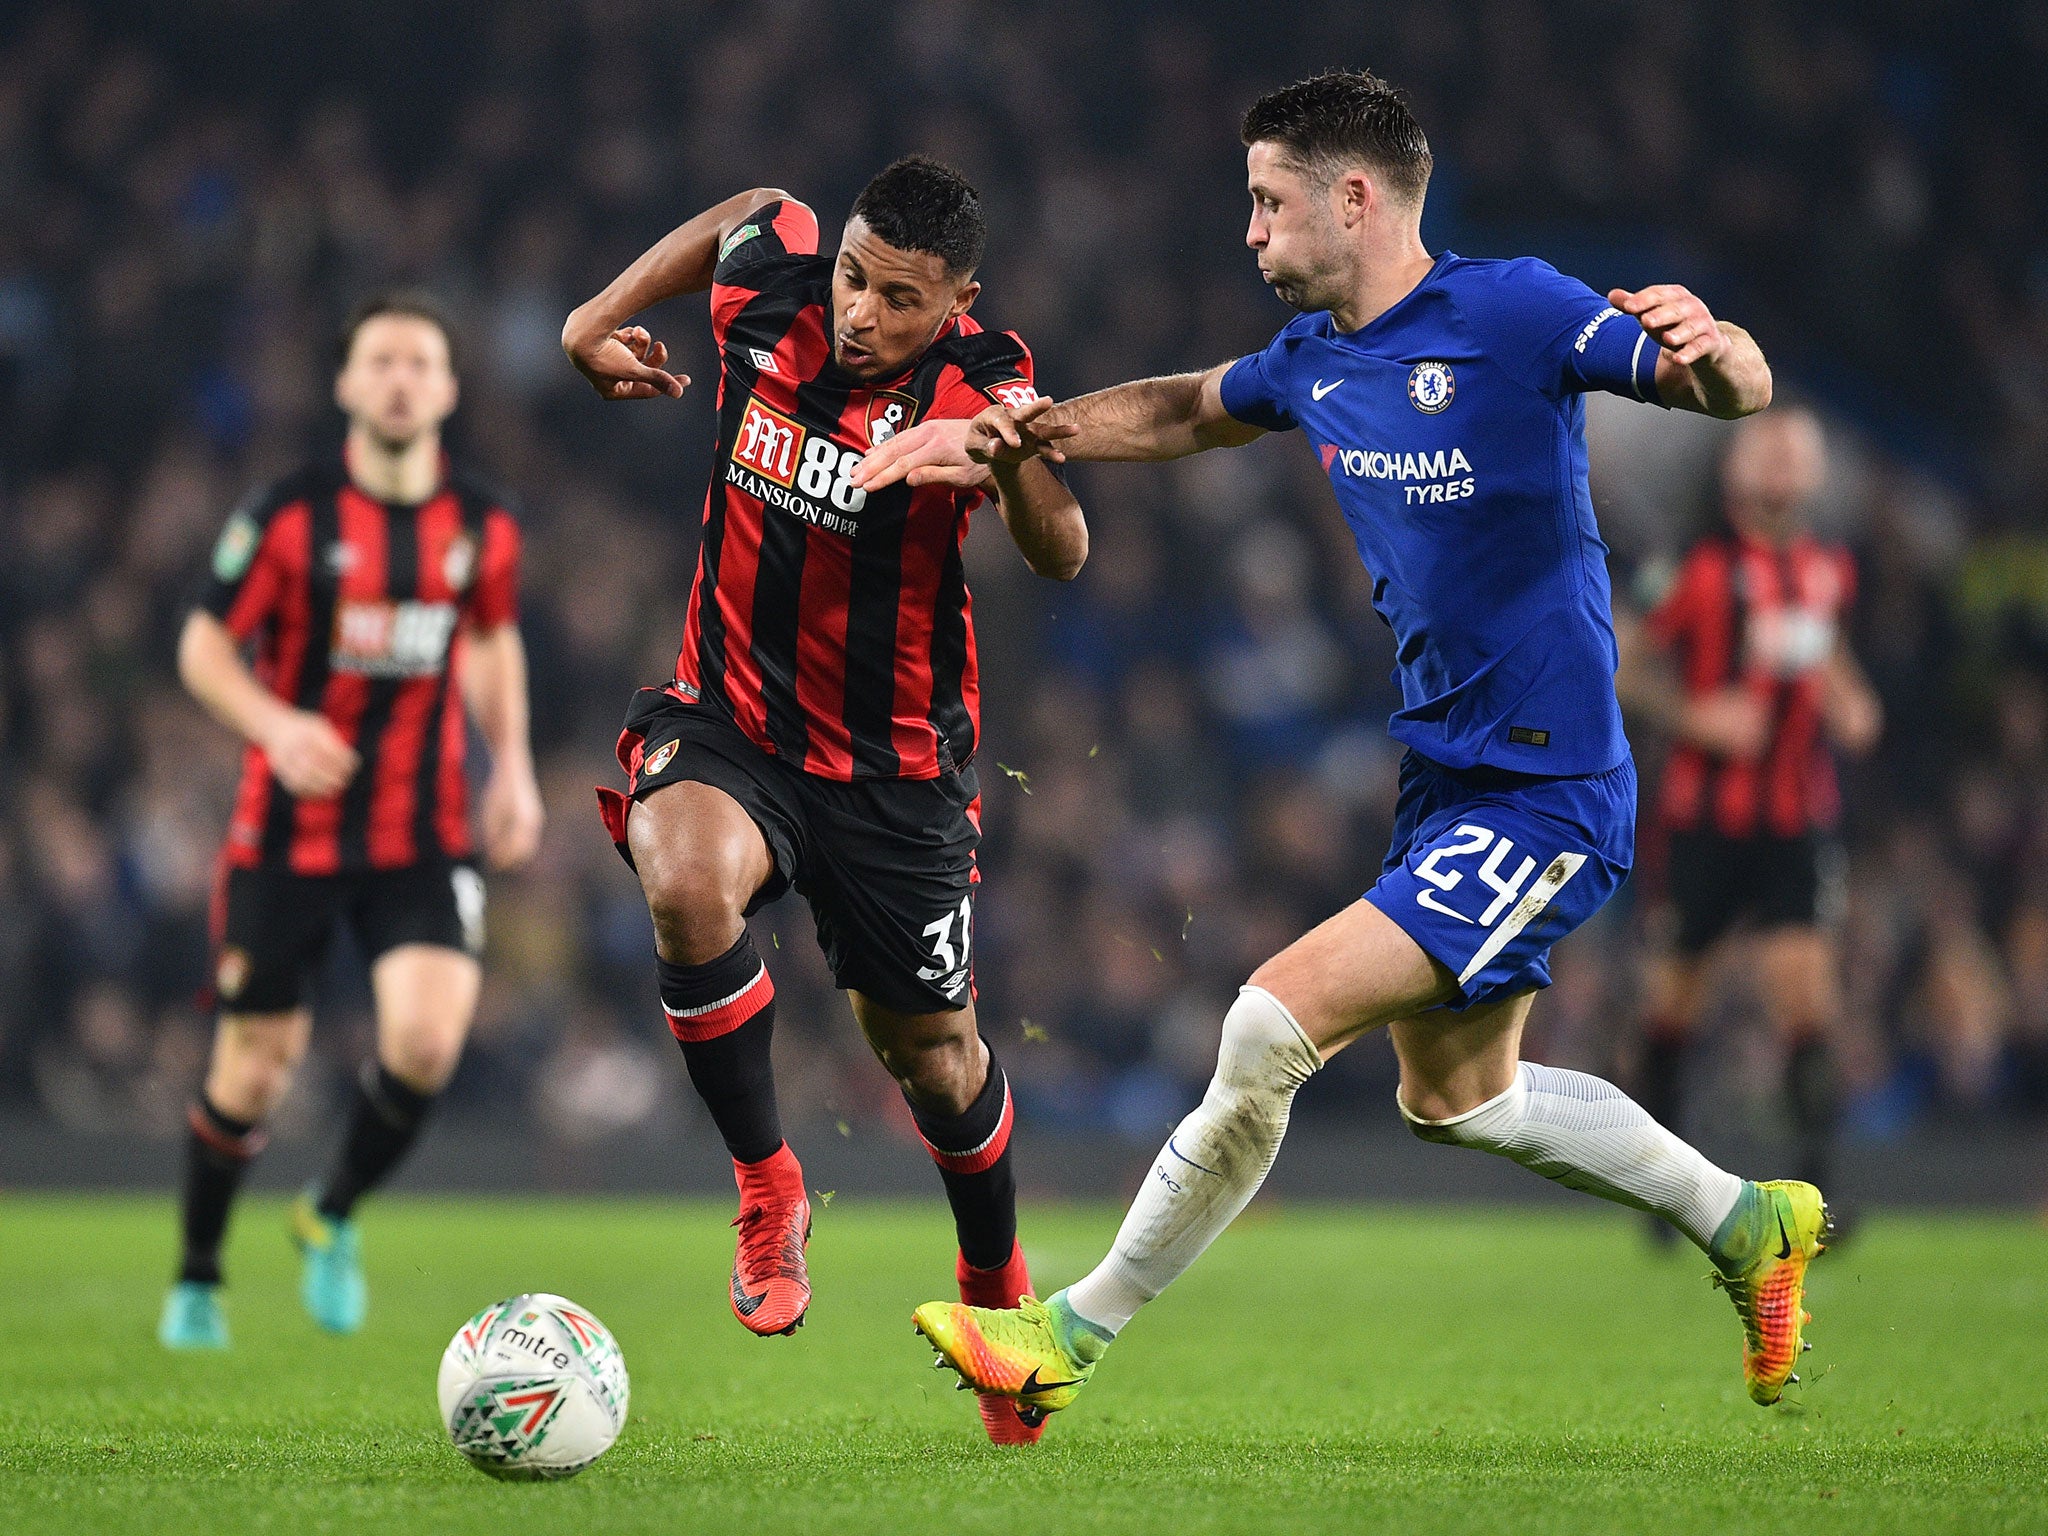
left=561, top=186, right=793, bottom=399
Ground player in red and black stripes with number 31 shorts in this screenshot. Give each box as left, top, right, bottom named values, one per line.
left=563, top=158, right=1087, bottom=1442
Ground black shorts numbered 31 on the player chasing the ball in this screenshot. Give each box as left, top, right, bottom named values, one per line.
left=600, top=688, right=981, bottom=1014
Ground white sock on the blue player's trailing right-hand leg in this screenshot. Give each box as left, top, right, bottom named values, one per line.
left=1395, top=1061, right=1743, bottom=1247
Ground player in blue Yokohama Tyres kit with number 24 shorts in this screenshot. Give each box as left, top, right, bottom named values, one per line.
left=856, top=72, right=1827, bottom=1411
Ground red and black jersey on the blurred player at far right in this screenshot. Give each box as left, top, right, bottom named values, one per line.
left=1649, top=532, right=1855, bottom=838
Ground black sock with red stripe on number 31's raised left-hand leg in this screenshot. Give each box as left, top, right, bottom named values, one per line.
left=655, top=932, right=782, bottom=1163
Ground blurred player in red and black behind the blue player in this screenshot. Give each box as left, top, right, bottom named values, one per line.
left=1620, top=408, right=1880, bottom=1231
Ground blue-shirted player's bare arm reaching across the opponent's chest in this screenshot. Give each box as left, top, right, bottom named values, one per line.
left=854, top=365, right=1264, bottom=492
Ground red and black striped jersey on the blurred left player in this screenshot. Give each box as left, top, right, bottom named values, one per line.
left=201, top=459, right=520, bottom=874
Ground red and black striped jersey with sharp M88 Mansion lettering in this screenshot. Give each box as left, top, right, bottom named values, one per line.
left=676, top=201, right=1036, bottom=780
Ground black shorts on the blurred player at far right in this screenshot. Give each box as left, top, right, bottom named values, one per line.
left=1667, top=831, right=1843, bottom=954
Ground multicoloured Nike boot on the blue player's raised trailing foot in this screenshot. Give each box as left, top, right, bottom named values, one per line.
left=1712, top=1180, right=1833, bottom=1407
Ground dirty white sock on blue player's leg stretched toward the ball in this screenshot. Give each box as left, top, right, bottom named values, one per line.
left=1067, top=987, right=1323, bottom=1335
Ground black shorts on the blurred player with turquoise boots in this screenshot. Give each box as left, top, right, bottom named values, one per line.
left=213, top=860, right=483, bottom=1014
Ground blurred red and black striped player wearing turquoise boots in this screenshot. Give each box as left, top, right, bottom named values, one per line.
left=160, top=295, right=541, bottom=1348
